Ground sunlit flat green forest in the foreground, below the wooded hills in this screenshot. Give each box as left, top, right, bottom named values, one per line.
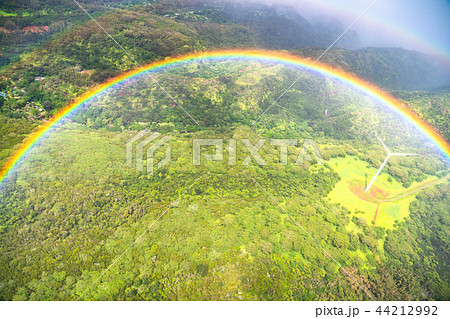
left=0, top=124, right=448, bottom=300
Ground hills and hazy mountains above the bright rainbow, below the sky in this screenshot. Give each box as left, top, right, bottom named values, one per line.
left=0, top=0, right=450, bottom=108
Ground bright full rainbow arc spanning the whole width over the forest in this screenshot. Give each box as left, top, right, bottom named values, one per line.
left=0, top=50, right=450, bottom=184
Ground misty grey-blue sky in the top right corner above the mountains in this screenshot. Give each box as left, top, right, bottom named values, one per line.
left=241, top=0, right=450, bottom=56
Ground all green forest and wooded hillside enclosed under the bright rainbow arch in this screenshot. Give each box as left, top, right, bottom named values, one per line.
left=0, top=61, right=448, bottom=300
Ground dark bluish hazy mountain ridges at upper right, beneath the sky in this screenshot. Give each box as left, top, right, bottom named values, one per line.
left=188, top=3, right=450, bottom=90
